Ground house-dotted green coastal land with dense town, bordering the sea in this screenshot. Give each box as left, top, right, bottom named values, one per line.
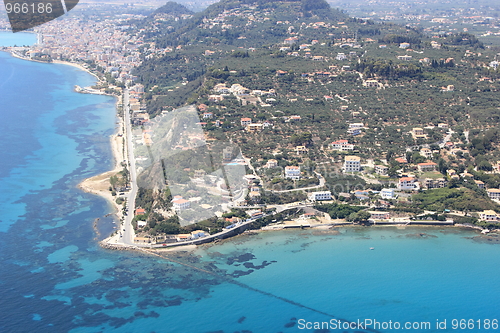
left=4, top=0, right=500, bottom=246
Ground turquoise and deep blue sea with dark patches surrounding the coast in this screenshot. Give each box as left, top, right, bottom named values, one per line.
left=0, top=33, right=500, bottom=333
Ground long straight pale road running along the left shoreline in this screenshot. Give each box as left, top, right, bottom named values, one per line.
left=119, top=89, right=137, bottom=245
